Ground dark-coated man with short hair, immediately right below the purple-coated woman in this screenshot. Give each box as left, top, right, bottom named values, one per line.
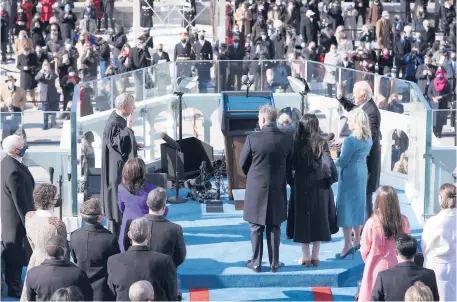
left=124, top=187, right=186, bottom=267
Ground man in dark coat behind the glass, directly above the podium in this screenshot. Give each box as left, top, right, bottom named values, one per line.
left=227, top=36, right=244, bottom=91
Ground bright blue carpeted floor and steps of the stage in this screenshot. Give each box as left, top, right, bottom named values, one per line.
left=3, top=184, right=422, bottom=301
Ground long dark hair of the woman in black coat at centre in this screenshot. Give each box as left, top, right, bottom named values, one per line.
left=294, top=114, right=325, bottom=164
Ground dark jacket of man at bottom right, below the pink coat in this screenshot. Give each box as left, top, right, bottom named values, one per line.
left=371, top=261, right=440, bottom=301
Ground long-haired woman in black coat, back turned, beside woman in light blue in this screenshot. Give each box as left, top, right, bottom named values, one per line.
left=287, top=114, right=338, bottom=267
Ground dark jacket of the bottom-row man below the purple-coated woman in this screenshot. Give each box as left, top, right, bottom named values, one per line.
left=108, top=245, right=178, bottom=301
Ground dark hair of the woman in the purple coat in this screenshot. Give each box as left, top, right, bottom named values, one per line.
left=122, top=158, right=146, bottom=195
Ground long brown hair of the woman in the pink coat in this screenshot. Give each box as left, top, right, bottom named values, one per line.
left=375, top=186, right=403, bottom=239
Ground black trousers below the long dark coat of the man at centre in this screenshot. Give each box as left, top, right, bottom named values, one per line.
left=249, top=223, right=281, bottom=266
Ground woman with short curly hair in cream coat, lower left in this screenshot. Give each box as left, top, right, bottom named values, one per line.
left=21, top=184, right=70, bottom=301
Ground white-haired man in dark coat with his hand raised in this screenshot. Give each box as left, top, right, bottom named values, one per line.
left=337, top=81, right=381, bottom=220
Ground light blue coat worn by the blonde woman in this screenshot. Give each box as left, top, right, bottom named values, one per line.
left=335, top=134, right=373, bottom=227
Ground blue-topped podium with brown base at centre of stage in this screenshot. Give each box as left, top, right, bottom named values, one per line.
left=221, top=91, right=274, bottom=201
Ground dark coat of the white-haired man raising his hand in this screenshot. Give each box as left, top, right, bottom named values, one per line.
left=338, top=97, right=381, bottom=193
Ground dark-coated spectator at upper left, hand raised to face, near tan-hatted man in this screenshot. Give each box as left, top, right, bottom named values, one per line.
left=35, top=61, right=59, bottom=130
